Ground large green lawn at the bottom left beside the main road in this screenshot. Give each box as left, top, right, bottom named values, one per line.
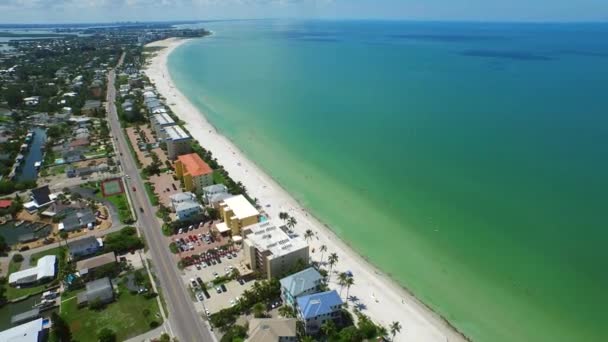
left=61, top=285, right=162, bottom=342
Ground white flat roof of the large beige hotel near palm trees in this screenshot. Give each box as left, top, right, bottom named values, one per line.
left=245, top=221, right=308, bottom=259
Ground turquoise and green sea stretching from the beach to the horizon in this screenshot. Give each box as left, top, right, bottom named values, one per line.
left=169, top=21, right=608, bottom=341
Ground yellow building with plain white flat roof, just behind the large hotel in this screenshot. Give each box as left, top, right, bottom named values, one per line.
left=216, top=195, right=260, bottom=235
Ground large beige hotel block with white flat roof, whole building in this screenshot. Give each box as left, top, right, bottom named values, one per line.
left=243, top=221, right=309, bottom=279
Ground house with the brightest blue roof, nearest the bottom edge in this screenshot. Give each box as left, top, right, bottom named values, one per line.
left=296, top=290, right=344, bottom=334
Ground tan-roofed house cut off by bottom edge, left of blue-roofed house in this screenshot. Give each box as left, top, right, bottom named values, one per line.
left=245, top=318, right=297, bottom=342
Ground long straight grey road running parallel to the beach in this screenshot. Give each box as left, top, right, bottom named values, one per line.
left=107, top=55, right=215, bottom=342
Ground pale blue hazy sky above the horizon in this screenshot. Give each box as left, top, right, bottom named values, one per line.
left=0, top=0, right=608, bottom=24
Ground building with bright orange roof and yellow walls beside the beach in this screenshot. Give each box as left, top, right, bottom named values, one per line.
left=175, top=153, right=213, bottom=193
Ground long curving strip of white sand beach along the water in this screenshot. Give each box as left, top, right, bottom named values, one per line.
left=145, top=38, right=469, bottom=341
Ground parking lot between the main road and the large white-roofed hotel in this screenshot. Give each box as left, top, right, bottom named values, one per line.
left=183, top=248, right=253, bottom=314
